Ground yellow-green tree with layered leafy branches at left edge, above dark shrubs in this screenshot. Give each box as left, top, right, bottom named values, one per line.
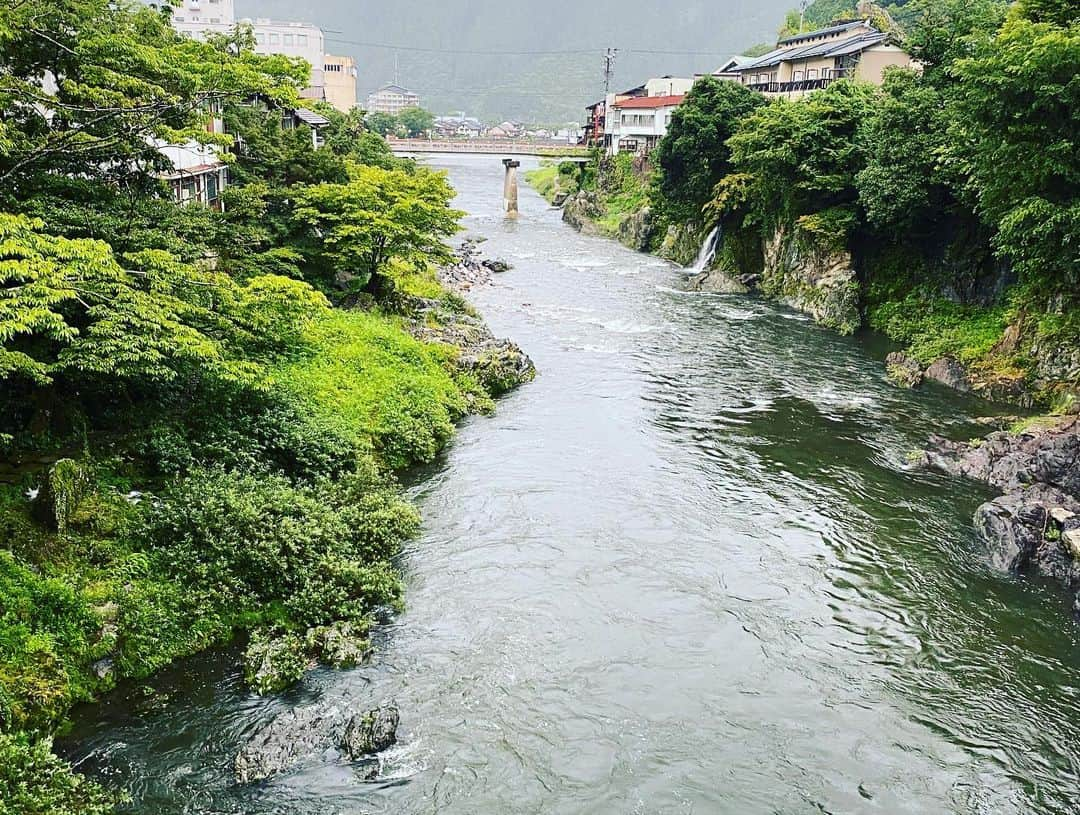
left=0, top=215, right=324, bottom=386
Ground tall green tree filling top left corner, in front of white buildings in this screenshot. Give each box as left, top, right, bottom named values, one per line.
left=0, top=0, right=308, bottom=208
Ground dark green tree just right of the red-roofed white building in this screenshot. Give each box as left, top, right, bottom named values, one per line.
left=650, top=77, right=765, bottom=222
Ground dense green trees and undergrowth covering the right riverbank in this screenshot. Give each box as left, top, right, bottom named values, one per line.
left=652, top=0, right=1080, bottom=402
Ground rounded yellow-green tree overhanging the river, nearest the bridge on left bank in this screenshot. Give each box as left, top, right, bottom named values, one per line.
left=294, top=165, right=463, bottom=294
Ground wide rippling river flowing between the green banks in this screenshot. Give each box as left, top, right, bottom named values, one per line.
left=65, top=155, right=1080, bottom=815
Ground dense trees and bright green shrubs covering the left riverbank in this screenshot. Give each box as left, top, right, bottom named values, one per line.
left=0, top=0, right=490, bottom=814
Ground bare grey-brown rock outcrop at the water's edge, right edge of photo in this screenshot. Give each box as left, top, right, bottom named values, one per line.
left=920, top=416, right=1080, bottom=613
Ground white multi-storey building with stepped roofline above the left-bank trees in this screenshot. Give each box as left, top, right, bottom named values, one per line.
left=172, top=0, right=326, bottom=99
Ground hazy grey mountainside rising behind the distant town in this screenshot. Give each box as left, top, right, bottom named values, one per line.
left=237, top=0, right=795, bottom=123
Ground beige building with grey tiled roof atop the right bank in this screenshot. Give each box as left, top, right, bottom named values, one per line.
left=729, top=21, right=916, bottom=97
